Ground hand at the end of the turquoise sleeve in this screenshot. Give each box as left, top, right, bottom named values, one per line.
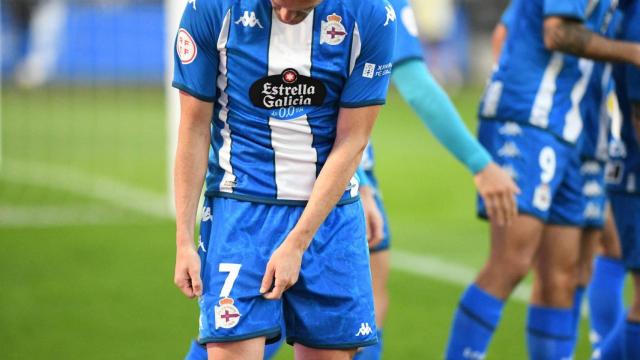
left=473, top=163, right=520, bottom=226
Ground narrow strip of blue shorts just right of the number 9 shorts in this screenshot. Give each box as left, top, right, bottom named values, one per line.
left=580, top=159, right=607, bottom=229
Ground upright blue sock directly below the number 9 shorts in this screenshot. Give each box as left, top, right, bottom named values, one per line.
left=527, top=305, right=574, bottom=360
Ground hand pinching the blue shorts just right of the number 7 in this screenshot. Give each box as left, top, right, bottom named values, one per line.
left=260, top=238, right=304, bottom=300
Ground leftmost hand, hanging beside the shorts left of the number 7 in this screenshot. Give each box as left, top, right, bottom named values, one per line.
left=173, top=244, right=202, bottom=299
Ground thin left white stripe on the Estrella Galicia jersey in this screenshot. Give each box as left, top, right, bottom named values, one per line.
left=217, top=10, right=236, bottom=192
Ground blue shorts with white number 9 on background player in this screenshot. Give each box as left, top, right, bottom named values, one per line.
left=478, top=120, right=584, bottom=227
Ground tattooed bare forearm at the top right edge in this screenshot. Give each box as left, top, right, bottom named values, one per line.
left=543, top=16, right=640, bottom=66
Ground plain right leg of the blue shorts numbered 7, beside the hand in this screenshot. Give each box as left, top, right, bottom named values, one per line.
left=283, top=202, right=377, bottom=349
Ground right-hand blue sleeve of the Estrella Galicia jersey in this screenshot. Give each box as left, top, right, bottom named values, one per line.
left=340, top=1, right=396, bottom=108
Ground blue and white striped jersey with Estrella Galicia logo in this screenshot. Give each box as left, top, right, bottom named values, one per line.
left=173, top=0, right=396, bottom=205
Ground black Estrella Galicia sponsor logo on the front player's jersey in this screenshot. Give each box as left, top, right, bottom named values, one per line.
left=249, top=69, right=327, bottom=109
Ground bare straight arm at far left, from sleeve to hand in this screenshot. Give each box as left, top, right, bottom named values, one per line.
left=174, top=92, right=213, bottom=298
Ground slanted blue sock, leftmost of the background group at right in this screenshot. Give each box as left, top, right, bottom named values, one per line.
left=446, top=284, right=504, bottom=360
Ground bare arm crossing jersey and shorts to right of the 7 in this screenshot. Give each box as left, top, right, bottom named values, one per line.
left=260, top=106, right=380, bottom=299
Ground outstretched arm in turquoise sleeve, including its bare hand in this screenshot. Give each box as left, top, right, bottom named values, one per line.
left=392, top=60, right=520, bottom=225
